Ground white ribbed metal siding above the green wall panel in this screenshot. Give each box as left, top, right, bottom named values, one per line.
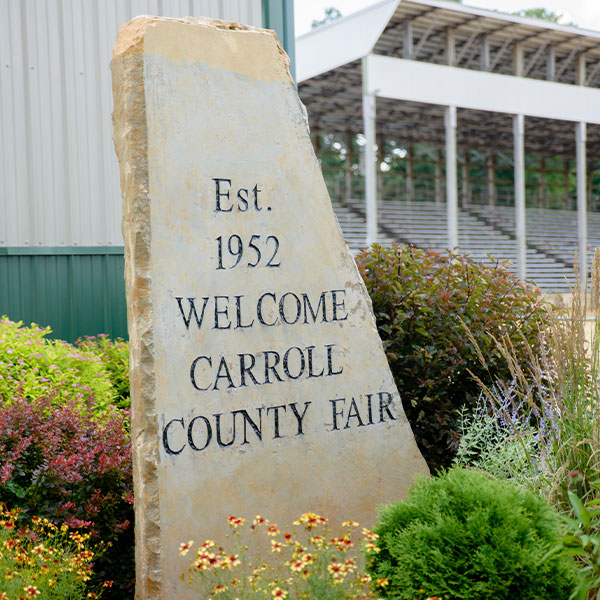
left=0, top=0, right=262, bottom=246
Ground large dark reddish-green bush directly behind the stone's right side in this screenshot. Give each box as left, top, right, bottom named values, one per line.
left=357, top=245, right=548, bottom=471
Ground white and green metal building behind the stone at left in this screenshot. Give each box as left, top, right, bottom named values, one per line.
left=0, top=0, right=294, bottom=339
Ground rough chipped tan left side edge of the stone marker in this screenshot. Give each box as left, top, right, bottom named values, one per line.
left=111, top=19, right=162, bottom=600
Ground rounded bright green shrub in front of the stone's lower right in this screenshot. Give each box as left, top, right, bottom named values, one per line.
left=368, top=469, right=575, bottom=600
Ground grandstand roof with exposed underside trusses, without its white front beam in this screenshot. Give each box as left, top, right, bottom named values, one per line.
left=296, top=0, right=600, bottom=156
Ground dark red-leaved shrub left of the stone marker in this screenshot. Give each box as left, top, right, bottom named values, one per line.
left=0, top=397, right=135, bottom=599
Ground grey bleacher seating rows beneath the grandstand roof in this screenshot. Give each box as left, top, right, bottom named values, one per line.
left=333, top=200, right=580, bottom=293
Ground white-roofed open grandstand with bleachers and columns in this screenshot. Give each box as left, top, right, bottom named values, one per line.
left=296, top=0, right=600, bottom=292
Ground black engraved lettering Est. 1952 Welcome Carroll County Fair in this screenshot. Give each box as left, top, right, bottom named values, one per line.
left=162, top=178, right=397, bottom=456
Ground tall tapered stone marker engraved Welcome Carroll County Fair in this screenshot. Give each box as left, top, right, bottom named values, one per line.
left=112, top=17, right=427, bottom=600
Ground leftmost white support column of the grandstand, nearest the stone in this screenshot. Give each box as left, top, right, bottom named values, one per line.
left=362, top=57, right=377, bottom=246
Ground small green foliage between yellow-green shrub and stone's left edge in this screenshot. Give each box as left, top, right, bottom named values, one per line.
left=75, top=334, right=131, bottom=409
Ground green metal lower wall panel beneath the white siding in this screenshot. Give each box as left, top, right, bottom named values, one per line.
left=0, top=247, right=127, bottom=341
